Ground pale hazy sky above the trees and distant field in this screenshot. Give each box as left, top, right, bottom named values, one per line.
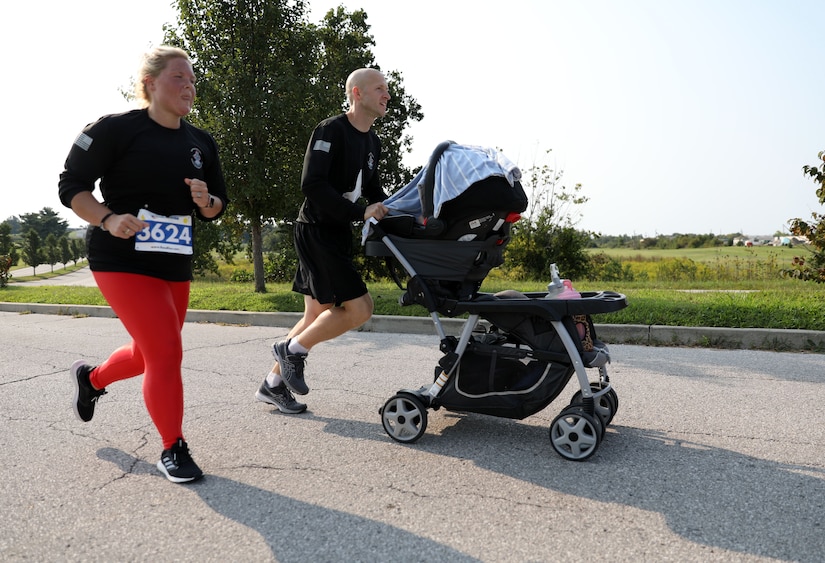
left=0, top=0, right=825, bottom=236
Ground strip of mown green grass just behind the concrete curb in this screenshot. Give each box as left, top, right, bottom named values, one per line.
left=0, top=268, right=825, bottom=331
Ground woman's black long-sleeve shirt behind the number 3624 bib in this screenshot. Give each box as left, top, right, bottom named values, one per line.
left=58, top=109, right=229, bottom=281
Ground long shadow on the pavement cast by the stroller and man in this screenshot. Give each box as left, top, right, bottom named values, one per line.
left=294, top=411, right=825, bottom=561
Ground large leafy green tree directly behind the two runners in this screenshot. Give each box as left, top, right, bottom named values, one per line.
left=165, top=0, right=420, bottom=292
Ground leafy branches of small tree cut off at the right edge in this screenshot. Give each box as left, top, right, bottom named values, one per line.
left=782, top=151, right=825, bottom=283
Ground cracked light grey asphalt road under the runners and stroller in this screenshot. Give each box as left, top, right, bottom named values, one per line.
left=0, top=312, right=825, bottom=562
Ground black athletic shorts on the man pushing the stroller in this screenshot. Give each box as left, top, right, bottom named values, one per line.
left=292, top=223, right=367, bottom=305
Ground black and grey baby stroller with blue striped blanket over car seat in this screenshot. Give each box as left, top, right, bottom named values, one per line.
left=362, top=141, right=627, bottom=461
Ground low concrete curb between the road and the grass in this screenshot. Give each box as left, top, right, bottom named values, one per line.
left=0, top=302, right=825, bottom=353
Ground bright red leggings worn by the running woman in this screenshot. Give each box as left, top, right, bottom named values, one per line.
left=89, top=272, right=189, bottom=449
